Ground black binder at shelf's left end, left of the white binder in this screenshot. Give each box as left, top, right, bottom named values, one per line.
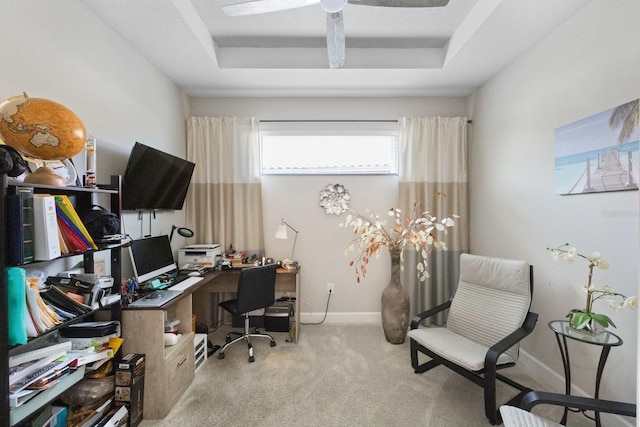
left=6, top=187, right=35, bottom=265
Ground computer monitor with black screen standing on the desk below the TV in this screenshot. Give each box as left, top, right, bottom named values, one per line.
left=129, top=234, right=178, bottom=283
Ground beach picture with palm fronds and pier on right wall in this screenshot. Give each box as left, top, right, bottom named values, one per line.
left=555, top=99, right=640, bottom=194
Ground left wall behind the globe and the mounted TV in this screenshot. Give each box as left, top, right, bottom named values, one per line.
left=0, top=0, right=187, bottom=272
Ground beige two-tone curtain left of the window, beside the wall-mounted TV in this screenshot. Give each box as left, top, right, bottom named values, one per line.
left=186, top=117, right=264, bottom=251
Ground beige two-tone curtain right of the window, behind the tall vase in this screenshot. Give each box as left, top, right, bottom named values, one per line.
left=399, top=117, right=469, bottom=323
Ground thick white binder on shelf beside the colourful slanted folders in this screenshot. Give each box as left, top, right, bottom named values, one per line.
left=33, top=194, right=61, bottom=261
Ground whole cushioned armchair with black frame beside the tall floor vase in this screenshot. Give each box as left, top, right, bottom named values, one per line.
left=408, top=254, right=538, bottom=424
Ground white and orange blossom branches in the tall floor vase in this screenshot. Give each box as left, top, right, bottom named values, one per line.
left=340, top=203, right=458, bottom=283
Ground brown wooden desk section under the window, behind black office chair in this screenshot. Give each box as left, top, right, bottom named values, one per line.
left=193, top=268, right=301, bottom=344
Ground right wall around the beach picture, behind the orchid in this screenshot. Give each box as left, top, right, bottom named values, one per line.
left=469, top=0, right=640, bottom=425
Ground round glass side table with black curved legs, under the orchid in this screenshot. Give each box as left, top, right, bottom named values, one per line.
left=549, top=320, right=622, bottom=427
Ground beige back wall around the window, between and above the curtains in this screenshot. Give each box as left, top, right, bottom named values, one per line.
left=190, top=98, right=466, bottom=322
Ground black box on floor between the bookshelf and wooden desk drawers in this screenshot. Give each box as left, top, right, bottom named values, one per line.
left=115, top=353, right=145, bottom=427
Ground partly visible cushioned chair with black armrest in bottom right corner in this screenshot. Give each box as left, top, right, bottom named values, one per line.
left=500, top=391, right=636, bottom=427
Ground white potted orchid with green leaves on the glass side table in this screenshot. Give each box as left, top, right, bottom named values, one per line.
left=547, top=243, right=638, bottom=329
